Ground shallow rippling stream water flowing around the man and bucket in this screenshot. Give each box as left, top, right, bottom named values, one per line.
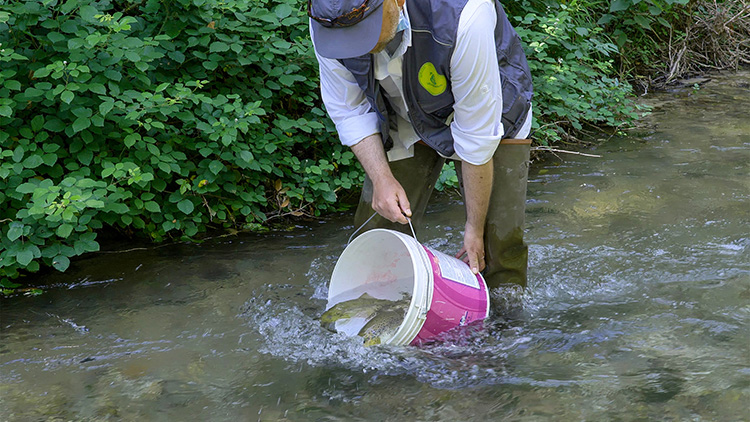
left=0, top=73, right=750, bottom=421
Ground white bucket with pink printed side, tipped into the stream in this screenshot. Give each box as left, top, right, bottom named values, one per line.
left=326, top=229, right=490, bottom=345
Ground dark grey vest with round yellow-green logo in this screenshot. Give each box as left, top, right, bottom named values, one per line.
left=339, top=0, right=533, bottom=157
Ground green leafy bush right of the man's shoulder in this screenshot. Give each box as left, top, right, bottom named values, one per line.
left=508, top=1, right=638, bottom=145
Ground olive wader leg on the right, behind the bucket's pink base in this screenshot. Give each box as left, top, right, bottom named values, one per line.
left=456, top=139, right=531, bottom=290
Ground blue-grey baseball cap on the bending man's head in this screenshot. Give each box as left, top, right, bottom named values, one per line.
left=307, top=0, right=383, bottom=59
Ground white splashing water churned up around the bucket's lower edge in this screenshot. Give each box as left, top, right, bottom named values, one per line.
left=241, top=278, right=525, bottom=389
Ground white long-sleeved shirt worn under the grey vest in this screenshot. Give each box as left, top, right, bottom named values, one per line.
left=316, top=0, right=531, bottom=165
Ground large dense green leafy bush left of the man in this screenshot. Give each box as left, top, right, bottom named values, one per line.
left=0, top=0, right=362, bottom=286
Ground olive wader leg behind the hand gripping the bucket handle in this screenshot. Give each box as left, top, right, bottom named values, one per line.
left=354, top=144, right=445, bottom=235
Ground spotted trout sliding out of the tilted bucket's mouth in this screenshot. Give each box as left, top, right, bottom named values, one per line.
left=320, top=293, right=411, bottom=346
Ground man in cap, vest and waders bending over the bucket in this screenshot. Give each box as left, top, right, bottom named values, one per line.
left=308, top=0, right=533, bottom=288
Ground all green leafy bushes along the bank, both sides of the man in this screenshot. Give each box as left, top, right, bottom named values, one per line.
left=0, top=0, right=744, bottom=294
